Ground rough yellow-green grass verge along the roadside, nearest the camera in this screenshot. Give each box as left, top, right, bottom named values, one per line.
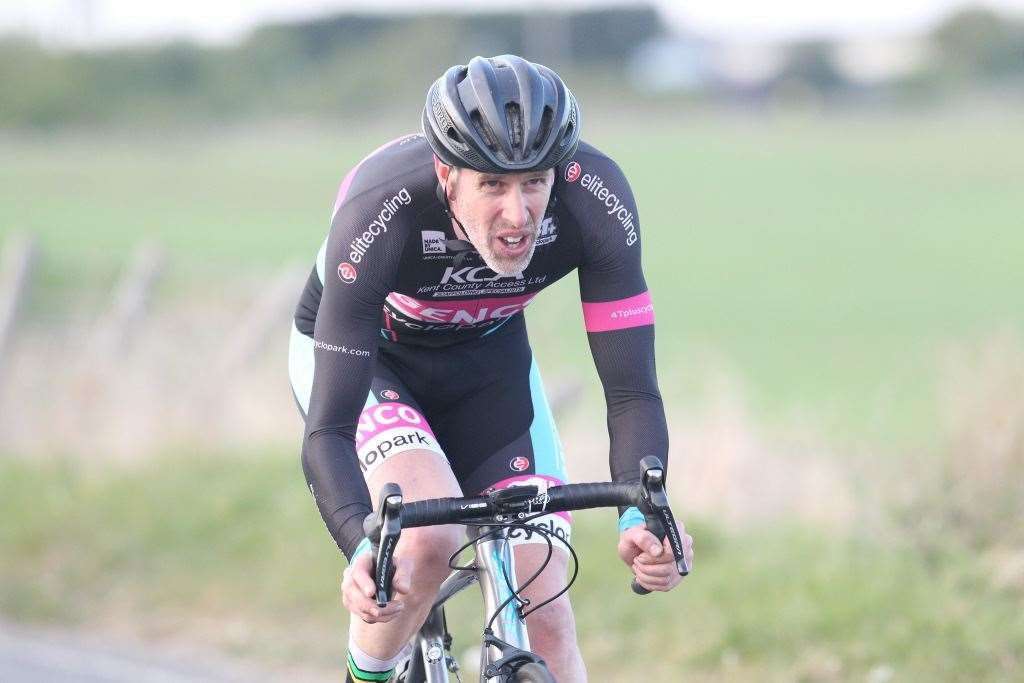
left=0, top=453, right=1024, bottom=681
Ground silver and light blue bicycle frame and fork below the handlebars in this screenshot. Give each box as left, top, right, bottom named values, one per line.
left=414, top=526, right=529, bottom=683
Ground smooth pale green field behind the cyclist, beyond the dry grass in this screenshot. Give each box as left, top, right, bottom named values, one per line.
left=0, top=119, right=1024, bottom=437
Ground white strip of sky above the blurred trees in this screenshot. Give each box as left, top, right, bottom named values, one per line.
left=0, top=0, right=1024, bottom=44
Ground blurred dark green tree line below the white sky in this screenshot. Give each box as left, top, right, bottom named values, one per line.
left=0, top=6, right=1024, bottom=129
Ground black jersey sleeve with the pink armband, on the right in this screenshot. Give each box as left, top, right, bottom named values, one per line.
left=566, top=149, right=669, bottom=491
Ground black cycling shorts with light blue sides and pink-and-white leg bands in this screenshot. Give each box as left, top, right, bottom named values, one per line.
left=289, top=317, right=570, bottom=545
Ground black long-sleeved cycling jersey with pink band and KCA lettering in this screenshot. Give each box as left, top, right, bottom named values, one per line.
left=295, top=134, right=668, bottom=557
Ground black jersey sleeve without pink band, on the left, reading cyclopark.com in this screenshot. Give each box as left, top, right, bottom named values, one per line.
left=302, top=169, right=403, bottom=558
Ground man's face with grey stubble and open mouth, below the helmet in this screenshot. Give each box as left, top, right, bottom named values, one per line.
left=438, top=166, right=555, bottom=275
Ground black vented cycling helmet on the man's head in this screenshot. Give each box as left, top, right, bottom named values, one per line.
left=423, top=54, right=580, bottom=173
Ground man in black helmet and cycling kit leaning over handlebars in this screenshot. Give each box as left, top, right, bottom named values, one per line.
left=289, top=55, right=692, bottom=683
